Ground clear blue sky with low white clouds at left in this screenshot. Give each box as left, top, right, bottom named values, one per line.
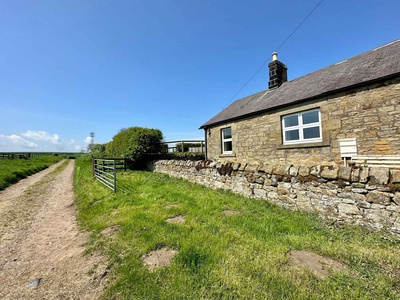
left=0, top=0, right=400, bottom=151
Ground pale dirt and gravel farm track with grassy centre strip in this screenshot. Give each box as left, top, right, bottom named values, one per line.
left=0, top=160, right=107, bottom=299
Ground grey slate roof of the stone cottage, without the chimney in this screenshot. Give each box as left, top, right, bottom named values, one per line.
left=200, top=40, right=400, bottom=128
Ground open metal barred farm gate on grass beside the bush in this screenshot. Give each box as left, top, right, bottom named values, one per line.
left=92, top=158, right=126, bottom=193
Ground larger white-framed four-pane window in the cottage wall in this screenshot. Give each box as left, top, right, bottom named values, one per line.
left=282, top=108, right=322, bottom=145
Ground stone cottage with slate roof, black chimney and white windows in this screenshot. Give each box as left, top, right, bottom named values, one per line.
left=201, top=40, right=400, bottom=166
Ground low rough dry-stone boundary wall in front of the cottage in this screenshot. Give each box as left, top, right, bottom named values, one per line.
left=152, top=160, right=400, bottom=235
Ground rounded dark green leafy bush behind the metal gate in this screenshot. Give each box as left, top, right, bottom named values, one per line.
left=106, top=127, right=163, bottom=161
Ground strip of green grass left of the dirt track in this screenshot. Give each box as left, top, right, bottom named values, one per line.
left=0, top=156, right=63, bottom=190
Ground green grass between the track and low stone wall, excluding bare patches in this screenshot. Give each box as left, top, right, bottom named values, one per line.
left=75, top=160, right=400, bottom=299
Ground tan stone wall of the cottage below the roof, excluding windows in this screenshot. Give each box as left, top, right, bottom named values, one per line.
left=206, top=78, right=400, bottom=166
